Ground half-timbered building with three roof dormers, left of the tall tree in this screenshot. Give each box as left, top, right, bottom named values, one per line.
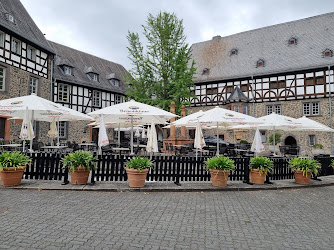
left=49, top=41, right=128, bottom=141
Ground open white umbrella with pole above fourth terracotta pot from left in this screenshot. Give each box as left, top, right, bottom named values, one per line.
left=198, top=107, right=261, bottom=155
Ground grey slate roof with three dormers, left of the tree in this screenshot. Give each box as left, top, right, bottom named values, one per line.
left=49, top=41, right=128, bottom=94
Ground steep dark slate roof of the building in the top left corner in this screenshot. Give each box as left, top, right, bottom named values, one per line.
left=0, top=0, right=53, bottom=53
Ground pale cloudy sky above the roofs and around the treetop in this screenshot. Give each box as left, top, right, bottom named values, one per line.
left=21, top=0, right=334, bottom=70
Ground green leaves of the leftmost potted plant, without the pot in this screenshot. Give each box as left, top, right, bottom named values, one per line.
left=0, top=152, right=31, bottom=171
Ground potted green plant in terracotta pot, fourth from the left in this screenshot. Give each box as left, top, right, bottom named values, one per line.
left=205, top=156, right=235, bottom=187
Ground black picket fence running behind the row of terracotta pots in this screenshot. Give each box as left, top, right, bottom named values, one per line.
left=23, top=153, right=334, bottom=184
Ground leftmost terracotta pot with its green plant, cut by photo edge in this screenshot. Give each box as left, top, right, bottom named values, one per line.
left=0, top=152, right=31, bottom=187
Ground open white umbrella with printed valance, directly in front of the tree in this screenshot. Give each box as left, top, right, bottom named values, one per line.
left=88, top=100, right=177, bottom=154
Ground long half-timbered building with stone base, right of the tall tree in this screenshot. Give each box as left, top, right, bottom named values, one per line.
left=190, top=13, right=334, bottom=153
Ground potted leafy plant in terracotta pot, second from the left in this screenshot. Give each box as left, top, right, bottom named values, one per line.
left=61, top=150, right=96, bottom=185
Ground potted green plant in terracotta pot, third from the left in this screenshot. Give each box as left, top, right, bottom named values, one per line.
left=125, top=156, right=153, bottom=187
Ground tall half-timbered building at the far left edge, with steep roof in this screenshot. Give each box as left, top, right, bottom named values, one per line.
left=0, top=0, right=54, bottom=143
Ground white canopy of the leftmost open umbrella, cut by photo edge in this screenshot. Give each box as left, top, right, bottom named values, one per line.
left=0, top=94, right=92, bottom=122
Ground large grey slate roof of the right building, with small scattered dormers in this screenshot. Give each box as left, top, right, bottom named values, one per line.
left=192, top=12, right=334, bottom=82
